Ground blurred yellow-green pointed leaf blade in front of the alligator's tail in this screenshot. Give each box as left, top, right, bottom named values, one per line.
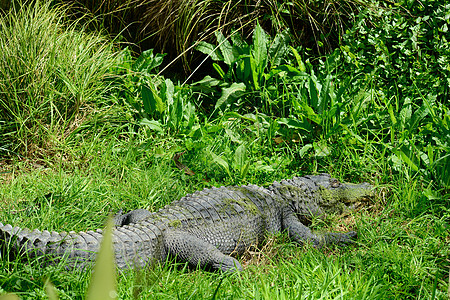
left=86, top=217, right=117, bottom=300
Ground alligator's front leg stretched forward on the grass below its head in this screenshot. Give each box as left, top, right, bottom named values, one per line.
left=283, top=213, right=357, bottom=248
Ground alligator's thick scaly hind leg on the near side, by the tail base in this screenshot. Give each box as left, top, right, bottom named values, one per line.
left=164, top=230, right=242, bottom=272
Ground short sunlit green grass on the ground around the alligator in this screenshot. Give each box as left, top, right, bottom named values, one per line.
left=0, top=127, right=449, bottom=299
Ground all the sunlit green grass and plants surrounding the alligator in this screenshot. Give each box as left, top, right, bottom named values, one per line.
left=0, top=0, right=450, bottom=299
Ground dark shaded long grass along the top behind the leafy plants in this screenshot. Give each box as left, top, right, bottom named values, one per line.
left=59, top=0, right=370, bottom=71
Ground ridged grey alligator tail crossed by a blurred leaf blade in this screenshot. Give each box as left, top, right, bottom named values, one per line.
left=0, top=222, right=165, bottom=269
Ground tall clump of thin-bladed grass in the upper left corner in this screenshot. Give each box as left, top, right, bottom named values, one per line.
left=0, top=1, right=120, bottom=154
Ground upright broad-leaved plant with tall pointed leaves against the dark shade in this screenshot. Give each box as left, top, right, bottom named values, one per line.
left=194, top=23, right=289, bottom=109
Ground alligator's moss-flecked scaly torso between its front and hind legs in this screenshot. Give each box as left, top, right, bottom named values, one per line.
left=153, top=185, right=281, bottom=254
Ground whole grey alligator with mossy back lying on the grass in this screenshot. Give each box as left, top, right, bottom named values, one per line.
left=0, top=174, right=373, bottom=272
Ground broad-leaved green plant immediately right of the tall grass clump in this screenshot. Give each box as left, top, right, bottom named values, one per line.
left=112, top=49, right=196, bottom=133
